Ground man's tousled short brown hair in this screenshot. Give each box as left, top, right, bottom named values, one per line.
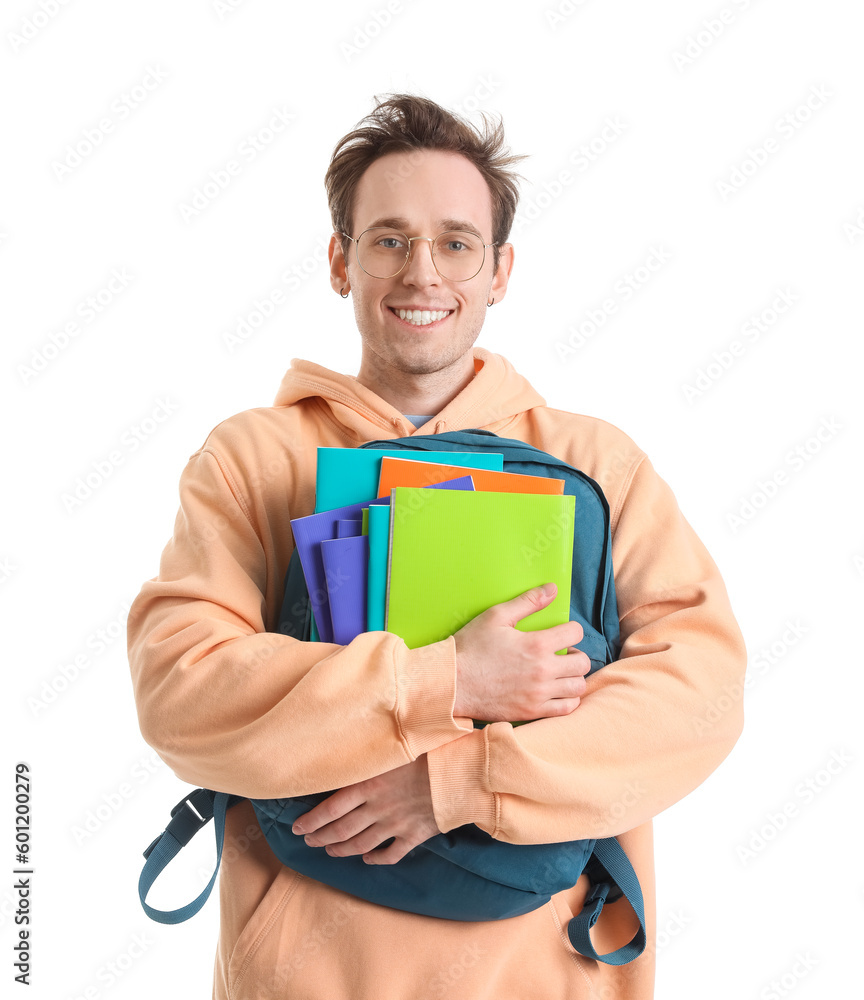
left=324, top=94, right=525, bottom=270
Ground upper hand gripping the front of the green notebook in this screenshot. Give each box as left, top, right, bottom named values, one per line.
left=453, top=583, right=591, bottom=722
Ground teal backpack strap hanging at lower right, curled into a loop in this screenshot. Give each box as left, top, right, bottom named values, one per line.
left=567, top=837, right=647, bottom=965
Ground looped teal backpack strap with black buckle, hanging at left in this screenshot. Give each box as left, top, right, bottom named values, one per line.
left=138, top=788, right=242, bottom=924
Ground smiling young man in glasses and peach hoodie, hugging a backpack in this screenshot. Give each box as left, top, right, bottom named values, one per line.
left=128, top=95, right=746, bottom=1000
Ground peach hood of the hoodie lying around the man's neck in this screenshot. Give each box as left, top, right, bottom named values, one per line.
left=274, top=347, right=545, bottom=441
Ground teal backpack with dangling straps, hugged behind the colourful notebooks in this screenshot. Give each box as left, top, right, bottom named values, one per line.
left=138, top=430, right=646, bottom=965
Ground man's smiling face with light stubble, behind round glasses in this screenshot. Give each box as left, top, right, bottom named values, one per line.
left=330, top=150, right=512, bottom=376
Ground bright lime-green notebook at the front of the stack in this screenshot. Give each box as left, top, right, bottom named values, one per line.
left=386, top=486, right=575, bottom=649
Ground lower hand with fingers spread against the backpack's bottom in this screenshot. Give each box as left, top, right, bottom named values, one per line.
left=291, top=754, right=441, bottom=865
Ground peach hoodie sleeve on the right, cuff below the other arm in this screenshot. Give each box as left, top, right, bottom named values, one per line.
left=428, top=455, right=746, bottom=843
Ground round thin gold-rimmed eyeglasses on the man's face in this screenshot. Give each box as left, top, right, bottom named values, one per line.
left=340, top=226, right=497, bottom=281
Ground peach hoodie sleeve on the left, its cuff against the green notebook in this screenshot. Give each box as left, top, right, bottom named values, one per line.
left=127, top=446, right=470, bottom=798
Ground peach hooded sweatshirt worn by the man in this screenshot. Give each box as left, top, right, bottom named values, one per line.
left=128, top=349, right=746, bottom=1000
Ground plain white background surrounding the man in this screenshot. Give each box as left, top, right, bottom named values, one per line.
left=0, top=0, right=864, bottom=1000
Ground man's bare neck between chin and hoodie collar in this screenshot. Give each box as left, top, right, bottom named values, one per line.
left=357, top=351, right=474, bottom=416
